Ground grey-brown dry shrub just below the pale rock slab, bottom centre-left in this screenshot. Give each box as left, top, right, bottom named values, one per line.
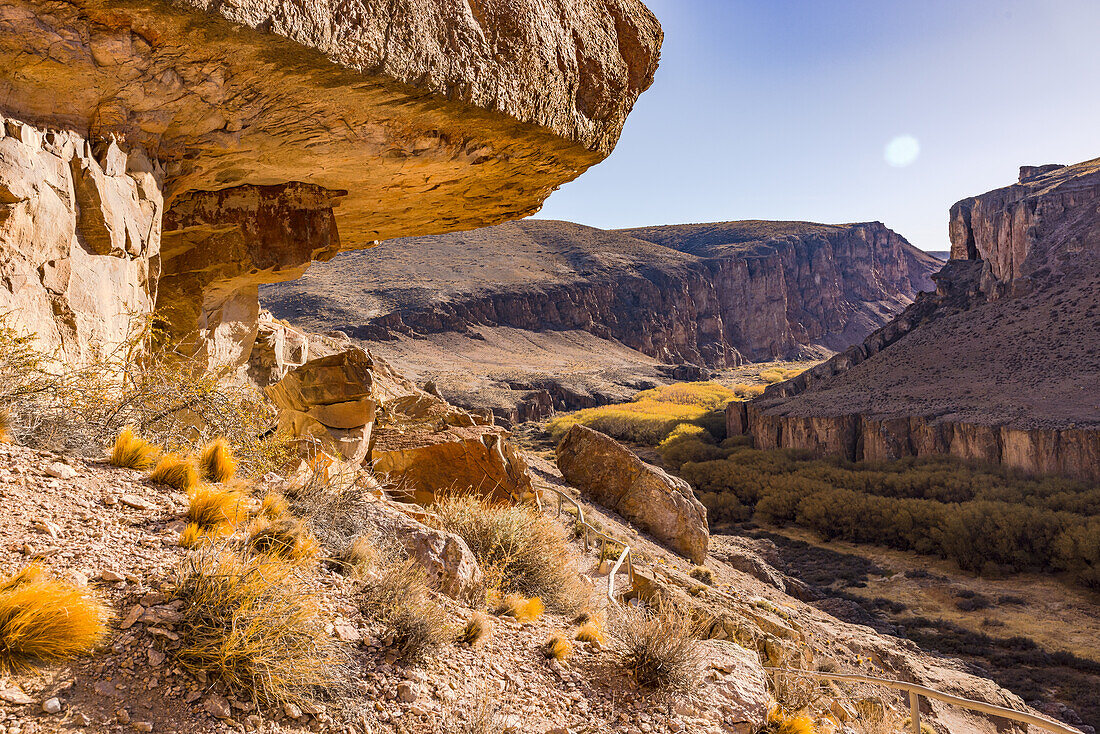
left=360, top=558, right=448, bottom=665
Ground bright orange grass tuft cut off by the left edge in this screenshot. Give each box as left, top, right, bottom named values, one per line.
left=0, top=565, right=110, bottom=672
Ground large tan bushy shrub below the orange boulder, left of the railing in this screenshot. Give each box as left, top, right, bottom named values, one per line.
left=432, top=494, right=589, bottom=613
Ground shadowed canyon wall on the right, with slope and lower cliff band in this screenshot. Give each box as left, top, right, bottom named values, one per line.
left=728, top=160, right=1100, bottom=481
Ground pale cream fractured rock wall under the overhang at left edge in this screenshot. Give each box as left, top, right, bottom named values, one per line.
left=0, top=113, right=163, bottom=364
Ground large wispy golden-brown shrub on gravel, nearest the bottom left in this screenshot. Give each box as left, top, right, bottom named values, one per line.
left=175, top=550, right=341, bottom=705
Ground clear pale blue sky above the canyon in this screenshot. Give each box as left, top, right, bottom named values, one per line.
left=538, top=0, right=1100, bottom=250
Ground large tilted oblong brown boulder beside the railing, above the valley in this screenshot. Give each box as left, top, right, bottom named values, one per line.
left=557, top=425, right=710, bottom=563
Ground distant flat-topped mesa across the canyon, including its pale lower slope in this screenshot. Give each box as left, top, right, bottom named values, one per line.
left=262, top=220, right=941, bottom=420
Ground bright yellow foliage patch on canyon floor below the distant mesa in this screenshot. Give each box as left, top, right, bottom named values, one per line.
left=547, top=382, right=736, bottom=445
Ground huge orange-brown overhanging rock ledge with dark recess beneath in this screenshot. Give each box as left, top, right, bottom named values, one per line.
left=0, top=0, right=661, bottom=359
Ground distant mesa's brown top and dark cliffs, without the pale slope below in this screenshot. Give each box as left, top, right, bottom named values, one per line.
left=264, top=221, right=938, bottom=366
